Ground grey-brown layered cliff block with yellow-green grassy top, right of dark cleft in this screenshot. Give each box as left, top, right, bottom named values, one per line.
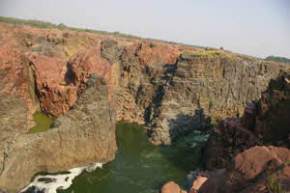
left=147, top=51, right=286, bottom=144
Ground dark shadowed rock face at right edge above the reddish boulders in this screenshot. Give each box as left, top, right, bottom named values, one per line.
left=255, top=72, right=290, bottom=147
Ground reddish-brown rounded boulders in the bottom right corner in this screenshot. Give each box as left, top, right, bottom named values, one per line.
left=198, top=146, right=290, bottom=193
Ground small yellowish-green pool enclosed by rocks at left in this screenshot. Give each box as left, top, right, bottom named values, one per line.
left=29, top=112, right=53, bottom=133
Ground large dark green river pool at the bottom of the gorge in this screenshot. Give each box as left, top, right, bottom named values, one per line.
left=62, top=123, right=206, bottom=193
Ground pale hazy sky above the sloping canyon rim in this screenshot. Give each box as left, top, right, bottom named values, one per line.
left=0, top=0, right=290, bottom=57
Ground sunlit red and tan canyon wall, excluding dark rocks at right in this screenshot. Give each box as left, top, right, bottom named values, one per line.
left=0, top=22, right=289, bottom=191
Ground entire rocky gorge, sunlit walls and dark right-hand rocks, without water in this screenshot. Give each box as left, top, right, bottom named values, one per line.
left=0, top=18, right=290, bottom=193
